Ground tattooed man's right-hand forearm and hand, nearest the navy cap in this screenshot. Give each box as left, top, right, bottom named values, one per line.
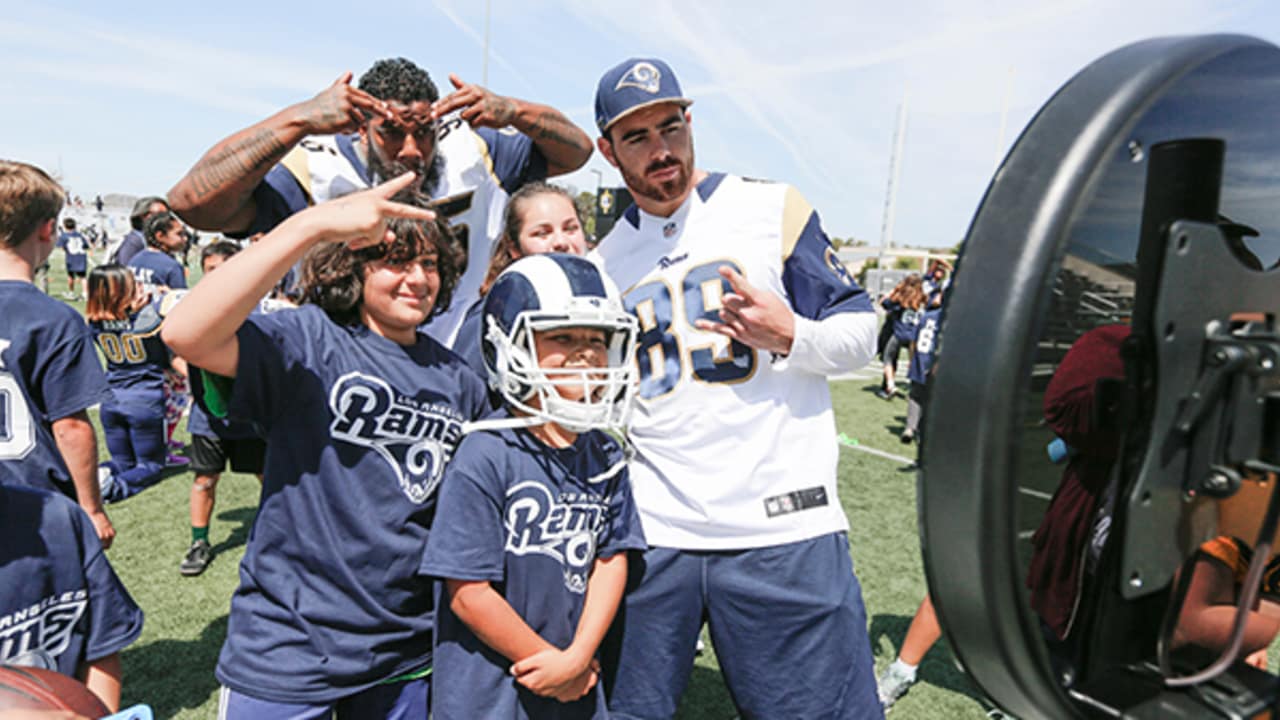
left=431, top=74, right=591, bottom=176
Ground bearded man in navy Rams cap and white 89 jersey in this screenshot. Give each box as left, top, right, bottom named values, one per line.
left=595, top=59, right=882, bottom=717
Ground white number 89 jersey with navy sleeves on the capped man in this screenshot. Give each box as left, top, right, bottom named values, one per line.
left=596, top=174, right=873, bottom=550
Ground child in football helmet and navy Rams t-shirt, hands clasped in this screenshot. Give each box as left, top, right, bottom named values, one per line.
left=422, top=254, right=645, bottom=720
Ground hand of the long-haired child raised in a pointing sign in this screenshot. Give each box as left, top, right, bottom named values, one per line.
left=305, top=173, right=435, bottom=250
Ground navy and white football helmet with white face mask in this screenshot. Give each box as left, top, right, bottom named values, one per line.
left=476, top=254, right=637, bottom=432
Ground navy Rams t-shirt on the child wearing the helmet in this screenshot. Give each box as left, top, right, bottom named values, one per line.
left=422, top=411, right=646, bottom=719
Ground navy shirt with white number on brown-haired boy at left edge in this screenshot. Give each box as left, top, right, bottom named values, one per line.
left=0, top=281, right=110, bottom=497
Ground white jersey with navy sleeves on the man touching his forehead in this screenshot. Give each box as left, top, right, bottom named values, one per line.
left=247, top=118, right=547, bottom=347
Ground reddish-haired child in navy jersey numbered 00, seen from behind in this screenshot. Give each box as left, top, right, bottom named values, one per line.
left=84, top=264, right=186, bottom=502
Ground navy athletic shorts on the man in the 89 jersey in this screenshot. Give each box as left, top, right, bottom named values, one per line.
left=602, top=533, right=883, bottom=719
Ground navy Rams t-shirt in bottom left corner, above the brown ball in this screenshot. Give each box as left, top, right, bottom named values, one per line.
left=0, top=486, right=142, bottom=676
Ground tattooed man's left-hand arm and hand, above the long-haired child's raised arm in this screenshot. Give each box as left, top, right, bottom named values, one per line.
left=169, top=72, right=389, bottom=232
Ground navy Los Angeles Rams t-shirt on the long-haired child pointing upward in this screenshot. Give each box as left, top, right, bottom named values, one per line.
left=216, top=305, right=485, bottom=703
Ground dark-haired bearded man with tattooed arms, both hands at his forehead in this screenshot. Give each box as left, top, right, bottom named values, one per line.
left=169, top=58, right=591, bottom=345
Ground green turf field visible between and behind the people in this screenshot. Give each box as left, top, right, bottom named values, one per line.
left=50, top=244, right=989, bottom=720
